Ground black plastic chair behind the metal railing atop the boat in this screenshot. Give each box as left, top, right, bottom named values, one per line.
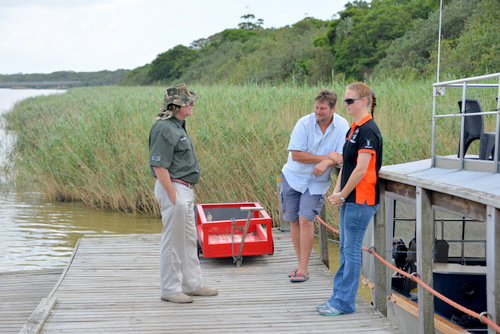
left=458, top=99, right=495, bottom=160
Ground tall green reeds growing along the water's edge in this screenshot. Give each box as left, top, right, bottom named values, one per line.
left=4, top=80, right=494, bottom=228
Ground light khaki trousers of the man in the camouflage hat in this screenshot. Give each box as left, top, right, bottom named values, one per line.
left=155, top=180, right=203, bottom=295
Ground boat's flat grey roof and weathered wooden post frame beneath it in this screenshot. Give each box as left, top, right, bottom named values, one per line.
left=370, top=156, right=500, bottom=333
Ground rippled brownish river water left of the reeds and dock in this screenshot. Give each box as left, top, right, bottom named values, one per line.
left=0, top=89, right=161, bottom=272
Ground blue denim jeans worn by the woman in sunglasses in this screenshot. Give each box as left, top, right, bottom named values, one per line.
left=328, top=203, right=378, bottom=314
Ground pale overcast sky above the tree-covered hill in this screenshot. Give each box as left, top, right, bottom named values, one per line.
left=0, top=0, right=348, bottom=74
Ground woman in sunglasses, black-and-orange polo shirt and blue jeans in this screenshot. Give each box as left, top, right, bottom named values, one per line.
left=317, top=82, right=382, bottom=315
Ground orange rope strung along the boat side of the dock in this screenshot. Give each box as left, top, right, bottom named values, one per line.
left=316, top=216, right=500, bottom=333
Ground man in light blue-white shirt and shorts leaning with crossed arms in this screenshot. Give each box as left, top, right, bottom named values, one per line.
left=281, top=89, right=349, bottom=282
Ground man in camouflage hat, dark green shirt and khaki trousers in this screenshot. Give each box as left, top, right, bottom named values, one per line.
left=149, top=84, right=218, bottom=303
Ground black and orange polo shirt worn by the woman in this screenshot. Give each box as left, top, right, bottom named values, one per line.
left=340, top=114, right=382, bottom=205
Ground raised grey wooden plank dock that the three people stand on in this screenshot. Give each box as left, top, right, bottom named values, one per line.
left=22, top=230, right=399, bottom=333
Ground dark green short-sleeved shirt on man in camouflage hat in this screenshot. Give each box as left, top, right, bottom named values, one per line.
left=149, top=117, right=200, bottom=184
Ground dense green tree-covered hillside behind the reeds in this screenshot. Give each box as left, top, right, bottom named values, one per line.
left=0, top=0, right=500, bottom=85
